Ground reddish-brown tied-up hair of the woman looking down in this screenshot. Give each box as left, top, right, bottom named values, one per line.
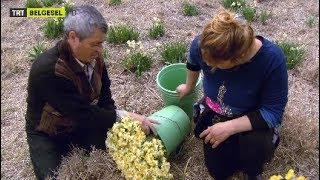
left=200, top=9, right=255, bottom=64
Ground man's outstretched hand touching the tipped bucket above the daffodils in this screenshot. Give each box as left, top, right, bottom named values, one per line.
left=129, top=113, right=160, bottom=135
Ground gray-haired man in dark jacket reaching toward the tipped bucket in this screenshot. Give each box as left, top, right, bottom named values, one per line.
left=26, top=6, right=156, bottom=179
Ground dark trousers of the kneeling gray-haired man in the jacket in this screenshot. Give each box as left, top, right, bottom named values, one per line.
left=27, top=128, right=107, bottom=180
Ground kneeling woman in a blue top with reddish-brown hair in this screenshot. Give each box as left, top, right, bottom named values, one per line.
left=177, top=10, right=288, bottom=180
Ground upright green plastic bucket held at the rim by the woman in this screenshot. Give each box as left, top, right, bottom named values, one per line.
left=156, top=63, right=201, bottom=119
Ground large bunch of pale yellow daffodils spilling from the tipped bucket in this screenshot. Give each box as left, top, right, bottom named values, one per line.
left=106, top=117, right=173, bottom=179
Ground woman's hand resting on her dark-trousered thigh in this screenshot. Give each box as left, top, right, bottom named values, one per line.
left=200, top=121, right=233, bottom=148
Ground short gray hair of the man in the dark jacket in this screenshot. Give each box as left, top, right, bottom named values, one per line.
left=63, top=5, right=108, bottom=40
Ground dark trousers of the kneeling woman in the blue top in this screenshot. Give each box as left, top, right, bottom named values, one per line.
left=194, top=99, right=279, bottom=180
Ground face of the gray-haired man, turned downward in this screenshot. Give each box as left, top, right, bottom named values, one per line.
left=68, top=28, right=106, bottom=63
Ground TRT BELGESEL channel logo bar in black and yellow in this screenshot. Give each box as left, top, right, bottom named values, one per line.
left=10, top=7, right=66, bottom=18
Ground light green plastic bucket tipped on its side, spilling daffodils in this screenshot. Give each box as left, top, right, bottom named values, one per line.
left=149, top=105, right=191, bottom=156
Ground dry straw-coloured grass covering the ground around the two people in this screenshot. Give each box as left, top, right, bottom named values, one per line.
left=1, top=0, right=319, bottom=179
